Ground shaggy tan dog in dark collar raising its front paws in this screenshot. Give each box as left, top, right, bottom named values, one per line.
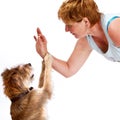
left=1, top=54, right=52, bottom=120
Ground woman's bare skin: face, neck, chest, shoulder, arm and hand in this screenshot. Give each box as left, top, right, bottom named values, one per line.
left=34, top=18, right=120, bottom=77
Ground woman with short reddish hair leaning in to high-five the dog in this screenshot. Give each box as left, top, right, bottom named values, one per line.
left=34, top=0, right=120, bottom=77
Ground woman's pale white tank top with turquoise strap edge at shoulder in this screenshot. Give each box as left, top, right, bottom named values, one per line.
left=86, top=14, right=120, bottom=62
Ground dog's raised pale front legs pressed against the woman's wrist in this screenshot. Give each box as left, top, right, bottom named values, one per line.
left=39, top=54, right=52, bottom=99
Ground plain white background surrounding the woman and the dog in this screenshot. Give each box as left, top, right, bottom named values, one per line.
left=0, top=0, right=120, bottom=120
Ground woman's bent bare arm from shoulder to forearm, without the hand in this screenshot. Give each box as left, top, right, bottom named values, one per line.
left=52, top=38, right=92, bottom=77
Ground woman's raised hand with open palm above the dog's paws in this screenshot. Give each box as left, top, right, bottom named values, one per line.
left=34, top=28, right=48, bottom=58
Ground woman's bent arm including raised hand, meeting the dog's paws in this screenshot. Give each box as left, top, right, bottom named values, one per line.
left=34, top=28, right=92, bottom=77
